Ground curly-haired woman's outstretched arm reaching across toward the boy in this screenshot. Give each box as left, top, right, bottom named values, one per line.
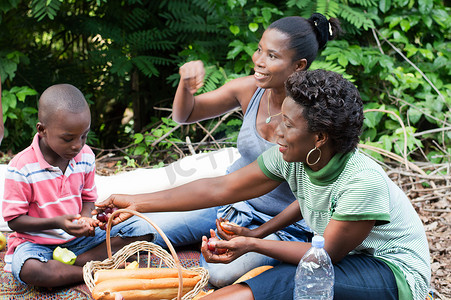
left=92, top=161, right=280, bottom=225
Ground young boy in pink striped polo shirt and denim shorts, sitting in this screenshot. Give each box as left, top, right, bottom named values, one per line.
left=3, top=84, right=153, bottom=287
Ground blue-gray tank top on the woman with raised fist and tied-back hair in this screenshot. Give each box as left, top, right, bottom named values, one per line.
left=228, top=88, right=295, bottom=216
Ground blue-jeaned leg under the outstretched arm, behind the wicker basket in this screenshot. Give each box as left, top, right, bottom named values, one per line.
left=144, top=207, right=218, bottom=248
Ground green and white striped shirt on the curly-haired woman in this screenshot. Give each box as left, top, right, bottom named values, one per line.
left=258, top=146, right=431, bottom=300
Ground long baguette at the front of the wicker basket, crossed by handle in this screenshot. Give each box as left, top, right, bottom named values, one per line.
left=92, top=275, right=201, bottom=300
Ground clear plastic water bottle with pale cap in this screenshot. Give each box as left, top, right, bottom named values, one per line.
left=293, top=235, right=335, bottom=300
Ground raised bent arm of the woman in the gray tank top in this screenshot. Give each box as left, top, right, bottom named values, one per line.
left=172, top=61, right=256, bottom=124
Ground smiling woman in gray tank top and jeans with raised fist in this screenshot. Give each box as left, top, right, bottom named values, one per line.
left=148, top=13, right=341, bottom=287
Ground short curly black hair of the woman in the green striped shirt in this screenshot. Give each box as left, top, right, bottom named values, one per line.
left=285, top=70, right=363, bottom=153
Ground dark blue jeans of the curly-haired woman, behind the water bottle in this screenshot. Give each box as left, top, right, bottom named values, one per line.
left=245, top=254, right=398, bottom=300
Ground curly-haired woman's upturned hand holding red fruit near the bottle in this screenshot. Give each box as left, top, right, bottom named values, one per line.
left=201, top=229, right=250, bottom=264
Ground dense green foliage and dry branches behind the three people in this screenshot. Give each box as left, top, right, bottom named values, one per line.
left=0, top=0, right=451, bottom=296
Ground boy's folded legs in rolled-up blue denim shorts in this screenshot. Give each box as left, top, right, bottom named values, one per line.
left=11, top=217, right=153, bottom=287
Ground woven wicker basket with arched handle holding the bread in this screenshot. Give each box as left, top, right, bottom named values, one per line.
left=83, top=209, right=209, bottom=300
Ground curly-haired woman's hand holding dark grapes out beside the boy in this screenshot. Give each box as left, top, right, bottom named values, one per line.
left=91, top=194, right=137, bottom=229
